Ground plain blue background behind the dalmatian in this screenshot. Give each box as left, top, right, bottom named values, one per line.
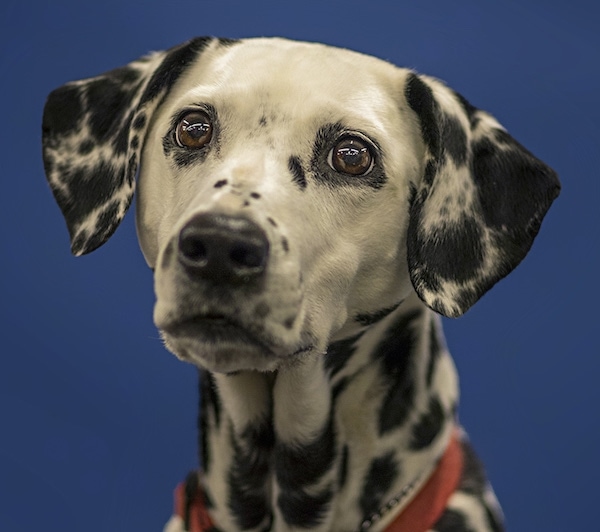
left=0, top=0, right=600, bottom=532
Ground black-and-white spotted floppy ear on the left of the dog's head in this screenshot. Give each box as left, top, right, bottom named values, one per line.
left=42, top=37, right=226, bottom=255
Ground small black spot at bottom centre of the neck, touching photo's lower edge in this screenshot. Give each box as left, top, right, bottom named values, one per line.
left=277, top=488, right=333, bottom=528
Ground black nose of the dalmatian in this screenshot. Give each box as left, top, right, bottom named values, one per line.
left=179, top=214, right=269, bottom=284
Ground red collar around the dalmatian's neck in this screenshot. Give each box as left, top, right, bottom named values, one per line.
left=175, top=432, right=463, bottom=532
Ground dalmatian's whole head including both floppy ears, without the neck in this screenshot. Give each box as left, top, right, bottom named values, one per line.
left=44, top=39, right=559, bottom=372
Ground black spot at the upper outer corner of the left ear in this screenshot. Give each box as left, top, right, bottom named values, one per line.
left=42, top=85, right=84, bottom=136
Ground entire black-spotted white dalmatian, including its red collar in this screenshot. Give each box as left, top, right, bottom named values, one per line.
left=43, top=38, right=560, bottom=532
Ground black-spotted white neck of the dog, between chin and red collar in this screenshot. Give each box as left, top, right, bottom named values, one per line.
left=199, top=298, right=458, bottom=531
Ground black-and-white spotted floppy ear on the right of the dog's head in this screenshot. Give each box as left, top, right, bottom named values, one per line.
left=405, top=73, right=560, bottom=317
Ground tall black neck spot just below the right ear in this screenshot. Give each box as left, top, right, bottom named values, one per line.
left=373, top=310, right=422, bottom=436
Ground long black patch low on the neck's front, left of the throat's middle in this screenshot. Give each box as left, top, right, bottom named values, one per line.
left=227, top=422, right=275, bottom=530
